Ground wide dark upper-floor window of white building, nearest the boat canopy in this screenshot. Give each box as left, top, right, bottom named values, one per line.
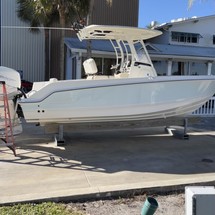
left=172, top=31, right=200, bottom=43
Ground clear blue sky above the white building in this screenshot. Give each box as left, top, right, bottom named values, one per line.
left=138, top=0, right=215, bottom=28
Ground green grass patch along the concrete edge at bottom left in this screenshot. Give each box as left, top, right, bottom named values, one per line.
left=0, top=202, right=83, bottom=215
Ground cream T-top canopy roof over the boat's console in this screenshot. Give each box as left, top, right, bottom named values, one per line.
left=78, top=25, right=162, bottom=40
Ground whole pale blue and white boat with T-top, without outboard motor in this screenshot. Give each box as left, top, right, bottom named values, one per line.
left=19, top=25, right=215, bottom=125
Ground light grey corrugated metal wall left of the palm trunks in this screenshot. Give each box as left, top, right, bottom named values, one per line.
left=1, top=0, right=45, bottom=81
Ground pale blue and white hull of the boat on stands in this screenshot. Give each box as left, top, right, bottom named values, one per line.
left=19, top=76, right=215, bottom=124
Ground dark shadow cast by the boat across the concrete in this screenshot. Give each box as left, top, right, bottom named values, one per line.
left=1, top=116, right=215, bottom=174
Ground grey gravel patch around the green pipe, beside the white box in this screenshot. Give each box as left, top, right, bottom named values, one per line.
left=68, top=193, right=185, bottom=215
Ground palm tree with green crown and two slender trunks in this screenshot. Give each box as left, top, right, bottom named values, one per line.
left=17, top=0, right=89, bottom=79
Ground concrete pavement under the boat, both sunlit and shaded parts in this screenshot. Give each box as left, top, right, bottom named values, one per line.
left=0, top=118, right=215, bottom=205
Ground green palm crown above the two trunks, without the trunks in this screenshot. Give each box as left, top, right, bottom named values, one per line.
left=17, top=0, right=90, bottom=27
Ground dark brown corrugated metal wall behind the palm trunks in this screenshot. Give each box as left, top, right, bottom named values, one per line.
left=49, top=0, right=139, bottom=79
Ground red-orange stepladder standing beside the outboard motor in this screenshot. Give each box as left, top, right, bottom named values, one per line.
left=0, top=81, right=16, bottom=156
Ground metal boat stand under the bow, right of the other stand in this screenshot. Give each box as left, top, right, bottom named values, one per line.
left=165, top=118, right=189, bottom=140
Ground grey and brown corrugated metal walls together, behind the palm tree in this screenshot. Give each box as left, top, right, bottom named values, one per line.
left=0, top=0, right=139, bottom=81
